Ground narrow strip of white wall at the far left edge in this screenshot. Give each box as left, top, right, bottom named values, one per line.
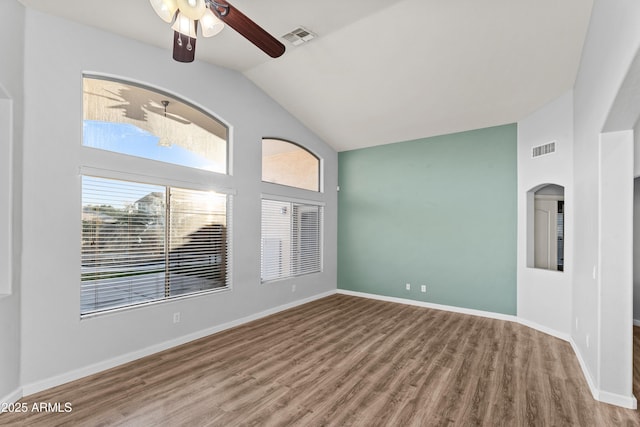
left=0, top=1, right=24, bottom=402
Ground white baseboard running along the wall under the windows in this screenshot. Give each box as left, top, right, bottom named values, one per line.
left=18, top=290, right=335, bottom=399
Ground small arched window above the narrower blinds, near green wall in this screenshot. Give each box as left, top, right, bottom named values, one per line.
left=262, top=138, right=320, bottom=191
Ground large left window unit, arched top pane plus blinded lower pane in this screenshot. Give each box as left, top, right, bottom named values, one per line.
left=80, top=76, right=232, bottom=316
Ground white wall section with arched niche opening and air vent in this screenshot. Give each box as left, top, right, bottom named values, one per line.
left=518, top=92, right=574, bottom=337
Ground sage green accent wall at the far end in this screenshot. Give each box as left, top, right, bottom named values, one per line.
left=338, top=124, right=517, bottom=314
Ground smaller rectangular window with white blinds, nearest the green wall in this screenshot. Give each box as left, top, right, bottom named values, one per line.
left=261, top=199, right=323, bottom=282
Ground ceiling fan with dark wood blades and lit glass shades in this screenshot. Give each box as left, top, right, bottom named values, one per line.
left=149, top=0, right=285, bottom=62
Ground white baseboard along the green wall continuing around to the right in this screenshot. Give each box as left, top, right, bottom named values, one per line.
left=337, top=289, right=640, bottom=409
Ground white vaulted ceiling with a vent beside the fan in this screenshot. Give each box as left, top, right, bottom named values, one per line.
left=21, top=0, right=593, bottom=151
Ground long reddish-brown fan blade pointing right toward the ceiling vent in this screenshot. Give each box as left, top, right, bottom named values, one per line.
left=213, top=0, right=285, bottom=58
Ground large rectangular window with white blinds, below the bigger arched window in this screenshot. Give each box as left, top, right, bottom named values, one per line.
left=81, top=175, right=230, bottom=315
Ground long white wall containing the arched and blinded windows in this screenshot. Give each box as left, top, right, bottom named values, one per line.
left=22, top=9, right=337, bottom=393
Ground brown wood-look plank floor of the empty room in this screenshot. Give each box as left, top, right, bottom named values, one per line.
left=0, top=295, right=640, bottom=427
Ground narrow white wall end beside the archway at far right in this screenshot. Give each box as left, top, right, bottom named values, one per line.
left=597, top=131, right=640, bottom=403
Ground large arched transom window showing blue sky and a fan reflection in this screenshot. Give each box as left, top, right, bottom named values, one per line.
left=83, top=76, right=228, bottom=173
